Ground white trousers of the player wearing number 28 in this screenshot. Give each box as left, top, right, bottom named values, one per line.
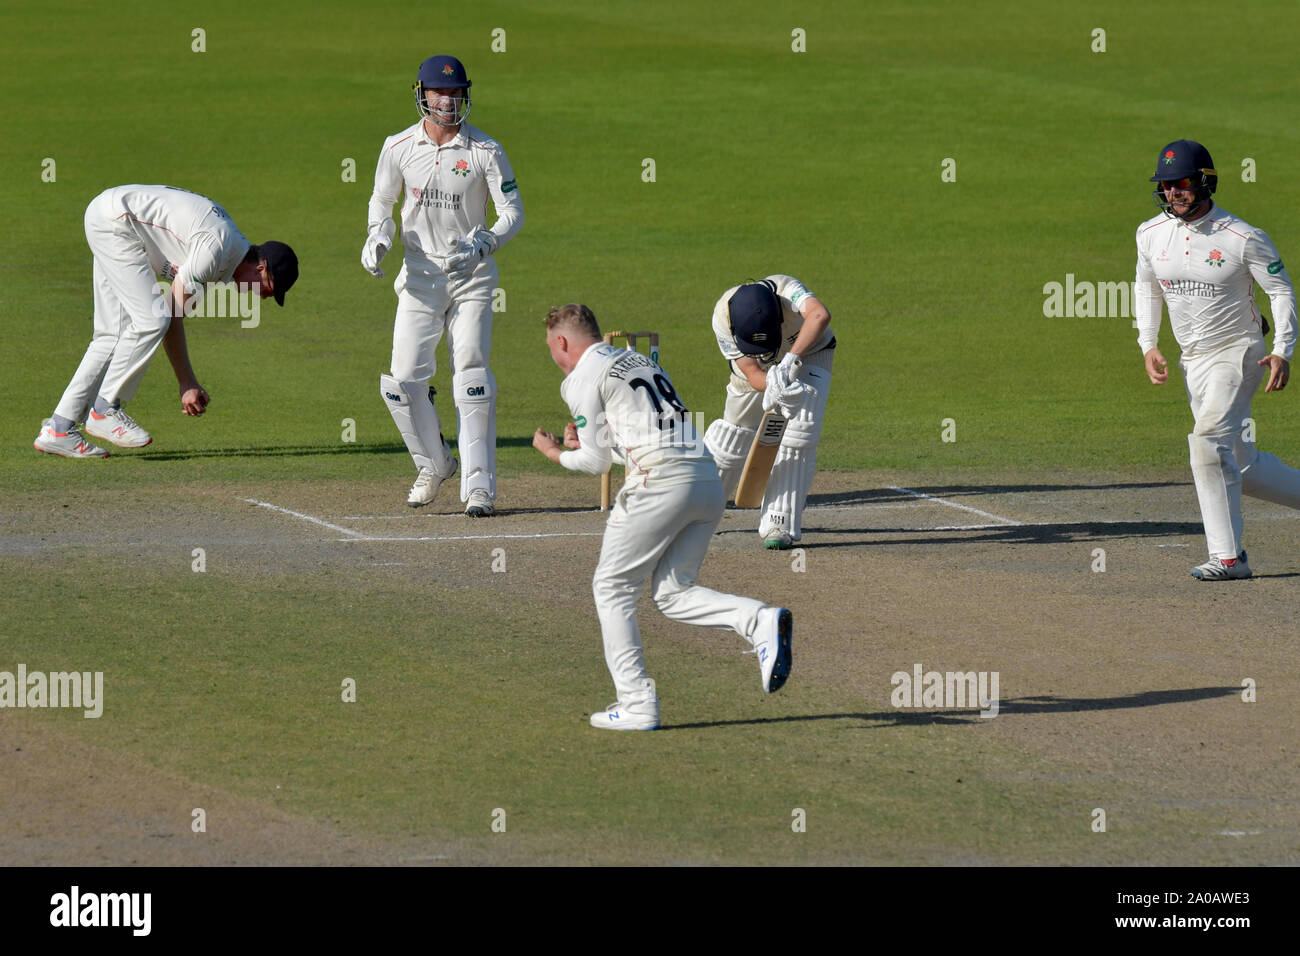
left=592, top=460, right=764, bottom=706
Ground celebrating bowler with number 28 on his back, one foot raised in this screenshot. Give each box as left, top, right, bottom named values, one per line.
left=533, top=304, right=794, bottom=730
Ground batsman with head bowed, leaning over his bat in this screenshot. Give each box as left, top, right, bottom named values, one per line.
left=705, top=274, right=835, bottom=550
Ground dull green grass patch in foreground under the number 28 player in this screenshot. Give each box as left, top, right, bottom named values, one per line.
left=5, top=556, right=1071, bottom=864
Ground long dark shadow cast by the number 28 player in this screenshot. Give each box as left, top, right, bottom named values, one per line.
left=659, top=687, right=1242, bottom=731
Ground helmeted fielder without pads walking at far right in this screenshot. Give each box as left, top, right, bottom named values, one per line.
left=1135, top=139, right=1300, bottom=581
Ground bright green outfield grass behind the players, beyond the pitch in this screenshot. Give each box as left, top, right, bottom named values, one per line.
left=0, top=3, right=1300, bottom=488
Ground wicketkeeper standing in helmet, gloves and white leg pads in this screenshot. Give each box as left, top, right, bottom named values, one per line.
left=361, top=56, right=524, bottom=518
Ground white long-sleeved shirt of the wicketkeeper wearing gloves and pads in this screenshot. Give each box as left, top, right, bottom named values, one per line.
left=368, top=120, right=524, bottom=263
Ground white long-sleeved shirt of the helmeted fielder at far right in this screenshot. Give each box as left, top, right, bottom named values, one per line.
left=1134, top=206, right=1296, bottom=362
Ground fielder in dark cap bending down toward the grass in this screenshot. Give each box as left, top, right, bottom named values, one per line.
left=34, top=186, right=298, bottom=458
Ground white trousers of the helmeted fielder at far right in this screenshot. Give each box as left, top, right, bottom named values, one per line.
left=1178, top=336, right=1300, bottom=558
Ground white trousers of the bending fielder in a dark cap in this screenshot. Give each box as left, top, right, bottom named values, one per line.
left=55, top=193, right=172, bottom=421
